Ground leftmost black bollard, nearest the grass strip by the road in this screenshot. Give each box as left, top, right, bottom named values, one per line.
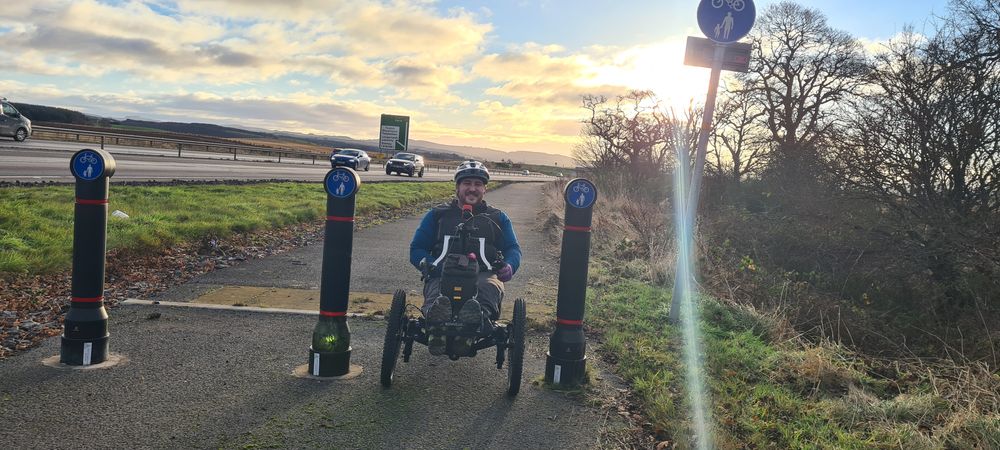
left=59, top=149, right=115, bottom=366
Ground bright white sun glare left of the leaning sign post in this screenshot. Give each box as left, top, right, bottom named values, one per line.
left=595, top=40, right=709, bottom=114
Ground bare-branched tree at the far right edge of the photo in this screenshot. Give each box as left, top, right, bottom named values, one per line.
left=838, top=9, right=1000, bottom=301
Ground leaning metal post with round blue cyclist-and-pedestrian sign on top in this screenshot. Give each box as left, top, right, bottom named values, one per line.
left=670, top=0, right=757, bottom=323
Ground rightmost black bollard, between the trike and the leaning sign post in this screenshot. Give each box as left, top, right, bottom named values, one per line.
left=545, top=178, right=597, bottom=386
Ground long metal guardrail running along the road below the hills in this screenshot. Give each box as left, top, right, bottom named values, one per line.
left=31, top=125, right=546, bottom=177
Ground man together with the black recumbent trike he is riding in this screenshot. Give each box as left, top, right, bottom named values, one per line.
left=381, top=161, right=527, bottom=395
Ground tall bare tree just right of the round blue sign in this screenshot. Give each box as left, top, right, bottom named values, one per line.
left=740, top=1, right=866, bottom=182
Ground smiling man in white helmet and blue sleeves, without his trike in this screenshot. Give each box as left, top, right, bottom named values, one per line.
left=410, top=161, right=521, bottom=355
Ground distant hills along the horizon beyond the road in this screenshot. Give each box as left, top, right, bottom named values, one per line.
left=14, top=103, right=576, bottom=167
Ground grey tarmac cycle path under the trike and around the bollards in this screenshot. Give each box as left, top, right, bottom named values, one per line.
left=0, top=183, right=625, bottom=449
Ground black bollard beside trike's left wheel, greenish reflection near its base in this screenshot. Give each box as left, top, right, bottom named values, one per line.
left=309, top=167, right=361, bottom=377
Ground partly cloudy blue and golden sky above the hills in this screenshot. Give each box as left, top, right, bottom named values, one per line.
left=0, top=0, right=948, bottom=155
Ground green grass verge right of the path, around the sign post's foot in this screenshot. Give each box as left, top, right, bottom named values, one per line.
left=588, top=266, right=1000, bottom=449
